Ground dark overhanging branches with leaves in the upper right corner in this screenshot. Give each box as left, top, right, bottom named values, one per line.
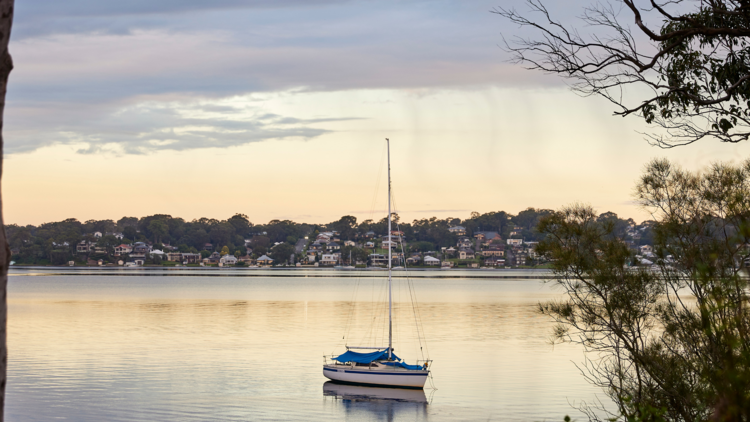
left=495, top=0, right=750, bottom=147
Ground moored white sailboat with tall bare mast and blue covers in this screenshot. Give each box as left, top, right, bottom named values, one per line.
left=323, top=138, right=432, bottom=389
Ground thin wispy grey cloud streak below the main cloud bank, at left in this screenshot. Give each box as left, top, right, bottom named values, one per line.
left=6, top=96, right=362, bottom=154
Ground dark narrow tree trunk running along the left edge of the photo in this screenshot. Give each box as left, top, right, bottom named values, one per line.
left=0, top=0, right=14, bottom=422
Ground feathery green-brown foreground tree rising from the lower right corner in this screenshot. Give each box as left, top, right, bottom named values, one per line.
left=539, top=160, right=750, bottom=421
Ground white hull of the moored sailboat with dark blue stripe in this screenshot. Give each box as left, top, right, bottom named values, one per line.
left=323, top=365, right=430, bottom=388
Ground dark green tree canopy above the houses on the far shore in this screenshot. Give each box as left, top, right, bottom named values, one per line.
left=6, top=208, right=650, bottom=265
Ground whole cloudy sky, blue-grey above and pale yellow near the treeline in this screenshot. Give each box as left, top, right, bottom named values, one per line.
left=2, top=0, right=750, bottom=224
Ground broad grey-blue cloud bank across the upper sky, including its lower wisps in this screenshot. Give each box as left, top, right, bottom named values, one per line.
left=6, top=0, right=576, bottom=153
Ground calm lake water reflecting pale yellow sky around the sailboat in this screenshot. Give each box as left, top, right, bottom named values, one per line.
left=6, top=268, right=606, bottom=421
